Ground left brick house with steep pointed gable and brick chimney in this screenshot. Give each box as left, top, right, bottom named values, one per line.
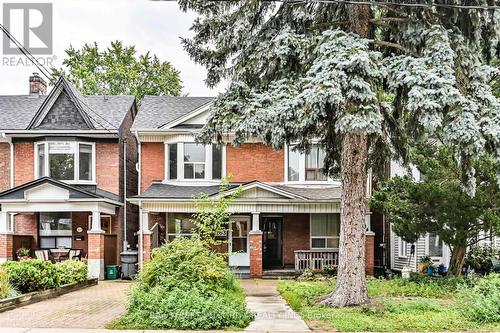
left=0, top=73, right=138, bottom=278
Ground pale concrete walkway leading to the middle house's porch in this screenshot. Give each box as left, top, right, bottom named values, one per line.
left=241, top=280, right=311, bottom=332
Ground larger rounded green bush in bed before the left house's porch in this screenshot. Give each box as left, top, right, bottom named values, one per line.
left=3, top=259, right=60, bottom=293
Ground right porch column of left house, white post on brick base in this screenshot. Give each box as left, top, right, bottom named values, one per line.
left=87, top=211, right=104, bottom=280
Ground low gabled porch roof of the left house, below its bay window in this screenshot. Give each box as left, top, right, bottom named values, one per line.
left=0, top=177, right=121, bottom=205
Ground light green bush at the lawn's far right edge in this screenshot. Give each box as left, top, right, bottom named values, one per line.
left=457, top=274, right=500, bottom=323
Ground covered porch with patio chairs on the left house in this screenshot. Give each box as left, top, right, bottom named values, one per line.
left=0, top=178, right=121, bottom=279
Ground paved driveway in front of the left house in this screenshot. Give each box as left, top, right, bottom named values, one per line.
left=0, top=280, right=132, bottom=328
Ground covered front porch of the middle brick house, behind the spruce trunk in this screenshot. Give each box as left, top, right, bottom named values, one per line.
left=129, top=182, right=374, bottom=277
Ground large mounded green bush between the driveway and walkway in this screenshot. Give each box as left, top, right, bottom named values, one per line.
left=114, top=239, right=253, bottom=330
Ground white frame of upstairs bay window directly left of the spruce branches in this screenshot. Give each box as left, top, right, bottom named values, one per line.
left=164, top=140, right=226, bottom=182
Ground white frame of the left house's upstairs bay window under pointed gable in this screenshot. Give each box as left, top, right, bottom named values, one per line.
left=34, top=140, right=96, bottom=185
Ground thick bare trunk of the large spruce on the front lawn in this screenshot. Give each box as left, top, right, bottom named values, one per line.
left=321, top=133, right=368, bottom=307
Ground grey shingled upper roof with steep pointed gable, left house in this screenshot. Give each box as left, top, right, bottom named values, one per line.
left=0, top=77, right=135, bottom=130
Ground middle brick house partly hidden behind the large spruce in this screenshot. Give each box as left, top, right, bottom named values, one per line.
left=129, top=96, right=382, bottom=277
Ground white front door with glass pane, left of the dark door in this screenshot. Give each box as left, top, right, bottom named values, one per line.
left=227, top=216, right=250, bottom=267
